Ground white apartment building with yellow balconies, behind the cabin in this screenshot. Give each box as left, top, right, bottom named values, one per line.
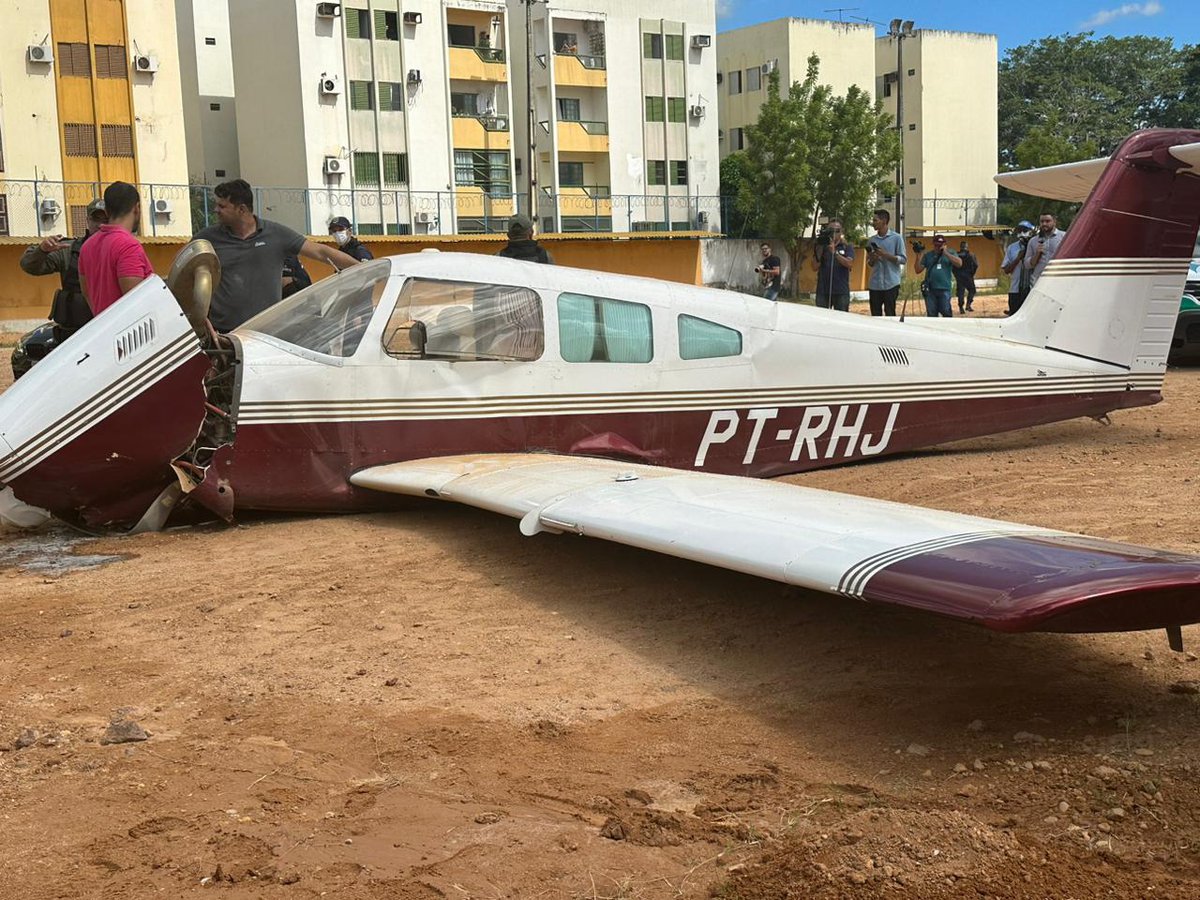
left=218, top=0, right=719, bottom=234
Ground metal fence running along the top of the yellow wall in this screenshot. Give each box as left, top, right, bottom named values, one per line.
left=0, top=179, right=996, bottom=238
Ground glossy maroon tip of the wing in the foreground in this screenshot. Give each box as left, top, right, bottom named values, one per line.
left=862, top=535, right=1200, bottom=632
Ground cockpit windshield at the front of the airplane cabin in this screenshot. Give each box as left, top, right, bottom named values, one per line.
left=239, top=259, right=391, bottom=356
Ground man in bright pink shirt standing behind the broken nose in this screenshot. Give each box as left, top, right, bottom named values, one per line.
left=79, top=181, right=154, bottom=316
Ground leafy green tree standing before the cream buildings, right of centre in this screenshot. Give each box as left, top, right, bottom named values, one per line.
left=737, top=54, right=900, bottom=289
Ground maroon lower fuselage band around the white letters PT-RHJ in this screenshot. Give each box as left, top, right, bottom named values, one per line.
left=222, top=390, right=1162, bottom=511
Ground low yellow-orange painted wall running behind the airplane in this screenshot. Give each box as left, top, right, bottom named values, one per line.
left=0, top=235, right=701, bottom=323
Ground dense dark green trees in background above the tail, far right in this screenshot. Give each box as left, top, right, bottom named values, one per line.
left=998, top=31, right=1195, bottom=169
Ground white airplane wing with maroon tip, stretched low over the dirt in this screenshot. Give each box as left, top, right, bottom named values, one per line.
left=350, top=454, right=1200, bottom=641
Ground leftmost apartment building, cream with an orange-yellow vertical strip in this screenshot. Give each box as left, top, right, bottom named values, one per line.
left=0, top=0, right=191, bottom=236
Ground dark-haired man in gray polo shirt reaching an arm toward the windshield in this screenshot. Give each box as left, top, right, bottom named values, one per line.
left=192, top=178, right=359, bottom=332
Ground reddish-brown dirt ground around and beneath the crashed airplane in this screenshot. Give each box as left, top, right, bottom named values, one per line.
left=0, top=292, right=1200, bottom=900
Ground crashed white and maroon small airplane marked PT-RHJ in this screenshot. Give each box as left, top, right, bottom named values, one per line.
left=0, top=131, right=1200, bottom=647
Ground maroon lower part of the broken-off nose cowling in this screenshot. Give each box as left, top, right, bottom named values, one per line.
left=10, top=350, right=210, bottom=526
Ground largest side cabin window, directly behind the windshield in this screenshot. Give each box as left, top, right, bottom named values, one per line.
left=383, top=278, right=545, bottom=361
